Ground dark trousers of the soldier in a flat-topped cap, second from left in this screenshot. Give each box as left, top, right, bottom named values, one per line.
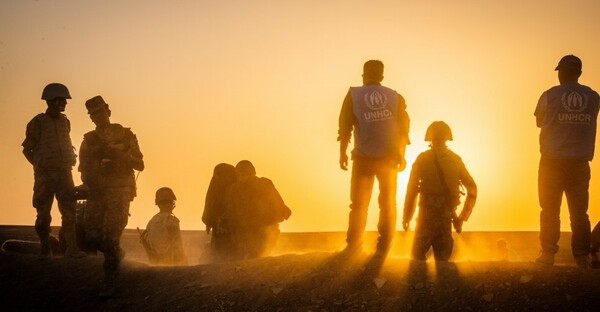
left=83, top=189, right=132, bottom=272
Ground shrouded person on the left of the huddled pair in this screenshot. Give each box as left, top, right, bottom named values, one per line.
left=202, top=163, right=236, bottom=259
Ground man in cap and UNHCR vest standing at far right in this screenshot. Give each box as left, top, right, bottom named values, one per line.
left=534, top=55, right=599, bottom=267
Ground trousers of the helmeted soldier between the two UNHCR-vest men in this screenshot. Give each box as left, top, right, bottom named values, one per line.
left=412, top=217, right=454, bottom=261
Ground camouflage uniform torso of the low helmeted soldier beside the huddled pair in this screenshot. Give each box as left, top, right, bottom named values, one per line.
left=146, top=212, right=187, bottom=265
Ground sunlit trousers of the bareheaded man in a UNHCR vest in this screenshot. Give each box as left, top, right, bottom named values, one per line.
left=346, top=157, right=398, bottom=251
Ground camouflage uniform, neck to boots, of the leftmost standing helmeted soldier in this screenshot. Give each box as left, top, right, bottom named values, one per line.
left=22, top=113, right=76, bottom=246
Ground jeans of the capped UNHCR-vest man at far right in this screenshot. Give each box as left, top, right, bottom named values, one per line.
left=538, top=156, right=591, bottom=257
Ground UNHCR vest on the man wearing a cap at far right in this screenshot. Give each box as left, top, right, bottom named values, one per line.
left=536, top=83, right=599, bottom=161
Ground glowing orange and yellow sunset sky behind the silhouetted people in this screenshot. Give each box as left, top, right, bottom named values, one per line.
left=0, top=0, right=600, bottom=232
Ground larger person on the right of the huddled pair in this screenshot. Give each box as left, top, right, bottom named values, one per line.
left=223, top=160, right=292, bottom=259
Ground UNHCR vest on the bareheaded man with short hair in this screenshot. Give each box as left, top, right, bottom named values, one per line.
left=350, top=85, right=400, bottom=157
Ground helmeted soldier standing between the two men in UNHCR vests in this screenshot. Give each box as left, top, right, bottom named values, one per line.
left=402, top=121, right=477, bottom=261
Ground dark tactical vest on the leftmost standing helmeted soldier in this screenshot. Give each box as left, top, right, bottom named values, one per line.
left=33, top=114, right=76, bottom=170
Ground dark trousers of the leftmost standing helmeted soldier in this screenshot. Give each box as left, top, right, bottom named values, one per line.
left=32, top=168, right=76, bottom=239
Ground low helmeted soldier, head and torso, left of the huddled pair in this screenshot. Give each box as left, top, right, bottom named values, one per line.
left=143, top=187, right=187, bottom=265
